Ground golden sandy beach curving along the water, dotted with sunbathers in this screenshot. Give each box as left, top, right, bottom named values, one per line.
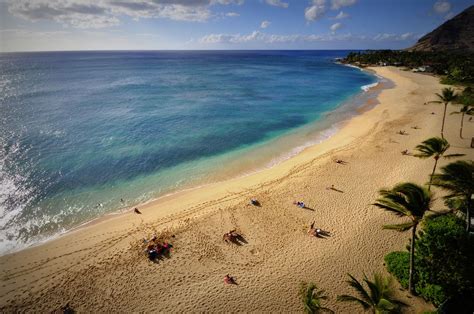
left=0, top=67, right=474, bottom=313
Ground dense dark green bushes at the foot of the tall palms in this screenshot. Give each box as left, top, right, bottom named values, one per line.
left=385, top=213, right=474, bottom=306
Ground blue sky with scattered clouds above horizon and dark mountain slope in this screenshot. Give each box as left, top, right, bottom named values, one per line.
left=0, top=0, right=472, bottom=52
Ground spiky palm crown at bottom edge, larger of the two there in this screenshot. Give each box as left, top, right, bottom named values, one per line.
left=337, top=273, right=406, bottom=313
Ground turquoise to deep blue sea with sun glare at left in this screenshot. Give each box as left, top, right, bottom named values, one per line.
left=0, top=51, right=377, bottom=254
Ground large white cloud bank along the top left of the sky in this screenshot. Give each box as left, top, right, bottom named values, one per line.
left=8, top=0, right=243, bottom=28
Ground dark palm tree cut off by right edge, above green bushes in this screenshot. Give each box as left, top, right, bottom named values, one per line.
left=432, top=160, right=474, bottom=232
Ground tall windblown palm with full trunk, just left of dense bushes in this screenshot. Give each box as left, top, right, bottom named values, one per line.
left=373, top=182, right=432, bottom=294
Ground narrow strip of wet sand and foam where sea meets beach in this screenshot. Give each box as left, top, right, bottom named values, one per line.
left=0, top=63, right=382, bottom=257
